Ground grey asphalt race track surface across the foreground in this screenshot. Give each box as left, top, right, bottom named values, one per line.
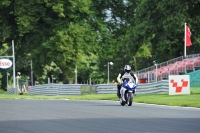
left=0, top=99, right=200, bottom=133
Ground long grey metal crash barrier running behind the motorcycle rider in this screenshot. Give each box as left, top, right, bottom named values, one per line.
left=29, top=80, right=169, bottom=95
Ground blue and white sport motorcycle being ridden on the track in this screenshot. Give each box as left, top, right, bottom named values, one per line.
left=120, top=78, right=137, bottom=106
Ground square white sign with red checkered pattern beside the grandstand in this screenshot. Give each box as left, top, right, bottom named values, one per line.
left=169, top=75, right=190, bottom=95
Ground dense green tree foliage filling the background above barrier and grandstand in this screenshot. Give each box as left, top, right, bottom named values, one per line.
left=0, top=0, right=200, bottom=88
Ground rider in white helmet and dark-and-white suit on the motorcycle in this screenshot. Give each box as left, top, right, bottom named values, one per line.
left=117, top=65, right=138, bottom=98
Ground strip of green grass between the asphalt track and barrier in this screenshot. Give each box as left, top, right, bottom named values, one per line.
left=0, top=93, right=200, bottom=108
